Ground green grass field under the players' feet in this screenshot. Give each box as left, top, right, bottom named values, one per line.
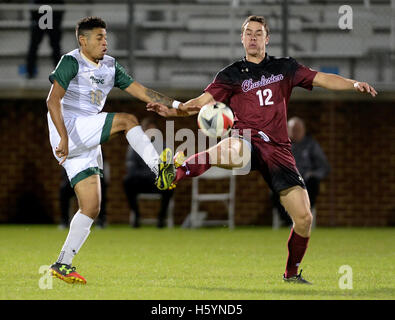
left=0, top=225, right=395, bottom=300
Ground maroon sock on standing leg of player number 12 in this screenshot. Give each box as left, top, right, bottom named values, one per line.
left=285, top=228, right=310, bottom=278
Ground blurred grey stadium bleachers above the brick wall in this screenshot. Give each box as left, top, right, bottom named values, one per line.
left=0, top=0, right=395, bottom=90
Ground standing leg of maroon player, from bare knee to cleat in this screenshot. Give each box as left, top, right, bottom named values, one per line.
left=280, top=186, right=313, bottom=284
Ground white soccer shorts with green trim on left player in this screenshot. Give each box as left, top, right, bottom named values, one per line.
left=47, top=112, right=115, bottom=187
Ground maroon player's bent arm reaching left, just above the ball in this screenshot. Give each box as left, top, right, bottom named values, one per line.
left=147, top=92, right=215, bottom=117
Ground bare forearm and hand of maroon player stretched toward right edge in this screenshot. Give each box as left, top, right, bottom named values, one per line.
left=313, top=72, right=377, bottom=97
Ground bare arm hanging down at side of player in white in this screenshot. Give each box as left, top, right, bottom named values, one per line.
left=47, top=80, right=69, bottom=164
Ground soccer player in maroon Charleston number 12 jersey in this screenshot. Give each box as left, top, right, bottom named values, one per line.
left=147, top=16, right=377, bottom=284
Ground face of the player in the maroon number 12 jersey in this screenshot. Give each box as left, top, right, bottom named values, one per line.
left=241, top=21, right=269, bottom=57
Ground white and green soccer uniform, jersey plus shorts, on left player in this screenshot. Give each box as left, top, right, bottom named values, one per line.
left=48, top=49, right=133, bottom=187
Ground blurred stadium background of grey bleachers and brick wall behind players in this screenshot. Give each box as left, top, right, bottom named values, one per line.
left=0, top=0, right=395, bottom=226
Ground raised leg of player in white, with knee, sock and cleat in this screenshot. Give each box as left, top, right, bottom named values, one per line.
left=110, top=113, right=175, bottom=190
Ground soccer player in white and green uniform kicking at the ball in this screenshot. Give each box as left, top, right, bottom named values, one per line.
left=47, top=17, right=180, bottom=284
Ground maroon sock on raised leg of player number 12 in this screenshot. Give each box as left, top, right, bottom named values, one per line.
left=174, top=151, right=211, bottom=182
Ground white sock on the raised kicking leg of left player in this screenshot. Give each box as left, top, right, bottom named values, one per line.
left=126, top=126, right=159, bottom=175
